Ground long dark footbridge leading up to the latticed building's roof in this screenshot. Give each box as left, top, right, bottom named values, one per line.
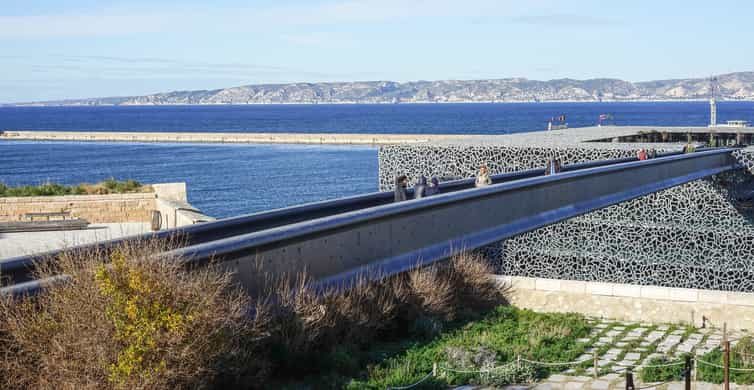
left=0, top=148, right=740, bottom=295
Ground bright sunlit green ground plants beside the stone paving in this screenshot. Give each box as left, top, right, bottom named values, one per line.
left=350, top=306, right=591, bottom=389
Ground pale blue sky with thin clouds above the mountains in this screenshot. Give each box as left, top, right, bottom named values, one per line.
left=0, top=0, right=754, bottom=103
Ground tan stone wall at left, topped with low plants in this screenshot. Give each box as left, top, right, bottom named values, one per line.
left=0, top=193, right=155, bottom=223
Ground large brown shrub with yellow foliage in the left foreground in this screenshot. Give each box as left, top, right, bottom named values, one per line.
left=0, top=238, right=264, bottom=389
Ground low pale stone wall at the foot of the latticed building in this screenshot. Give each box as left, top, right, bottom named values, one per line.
left=497, top=276, right=754, bottom=329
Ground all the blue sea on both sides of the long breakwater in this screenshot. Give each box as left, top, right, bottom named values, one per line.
left=0, top=102, right=754, bottom=218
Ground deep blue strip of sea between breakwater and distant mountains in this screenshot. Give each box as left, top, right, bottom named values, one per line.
left=0, top=102, right=754, bottom=134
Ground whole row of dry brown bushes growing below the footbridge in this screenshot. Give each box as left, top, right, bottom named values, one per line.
left=0, top=241, right=505, bottom=389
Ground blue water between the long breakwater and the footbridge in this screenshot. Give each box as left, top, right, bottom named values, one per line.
left=0, top=141, right=377, bottom=217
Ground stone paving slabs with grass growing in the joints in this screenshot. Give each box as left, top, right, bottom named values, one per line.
left=456, top=319, right=754, bottom=390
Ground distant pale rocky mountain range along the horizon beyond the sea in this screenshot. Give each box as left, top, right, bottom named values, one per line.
left=10, top=72, right=754, bottom=105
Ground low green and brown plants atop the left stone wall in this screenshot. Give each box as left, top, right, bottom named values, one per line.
left=0, top=179, right=154, bottom=197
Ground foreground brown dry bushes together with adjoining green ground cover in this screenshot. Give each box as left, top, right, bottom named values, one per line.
left=0, top=241, right=536, bottom=389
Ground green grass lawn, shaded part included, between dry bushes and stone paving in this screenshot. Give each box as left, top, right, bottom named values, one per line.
left=274, top=306, right=591, bottom=389
